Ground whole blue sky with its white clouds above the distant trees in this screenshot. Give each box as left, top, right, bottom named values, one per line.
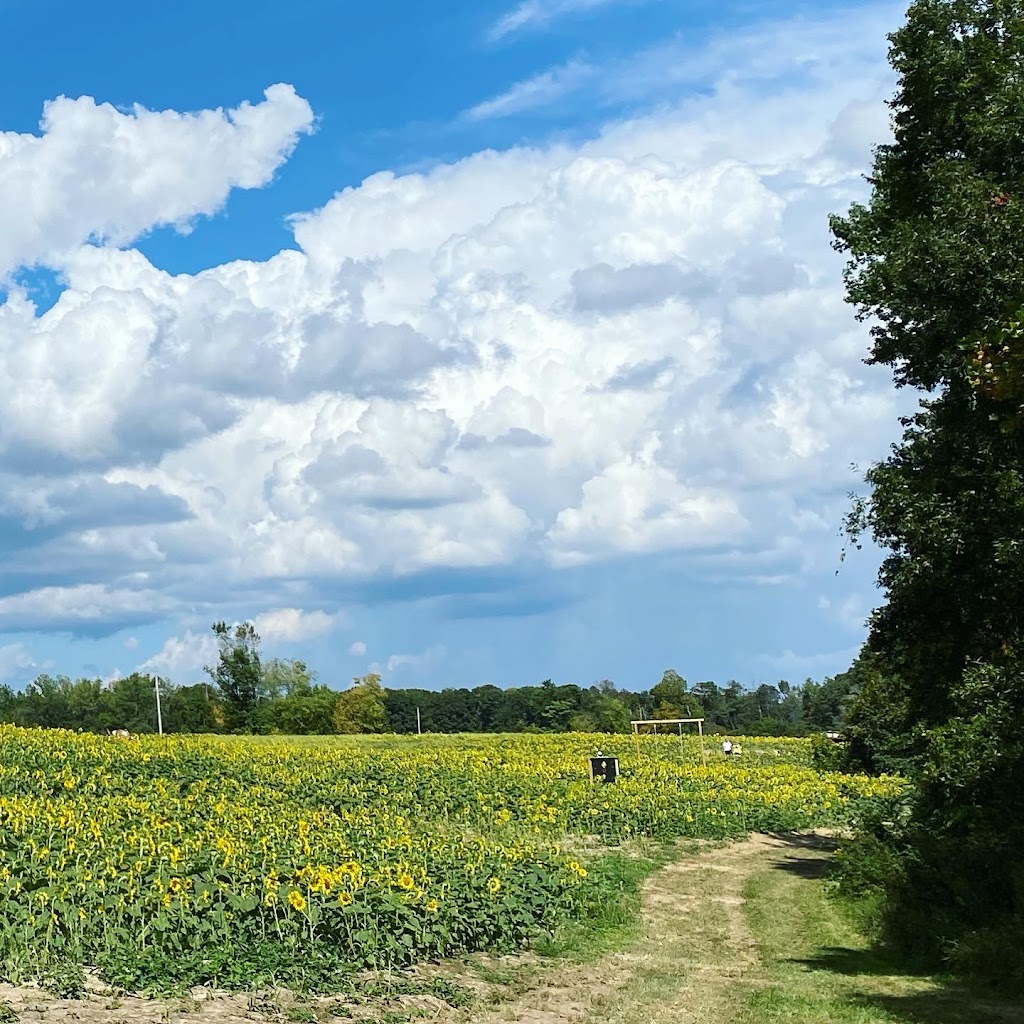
left=0, top=0, right=908, bottom=687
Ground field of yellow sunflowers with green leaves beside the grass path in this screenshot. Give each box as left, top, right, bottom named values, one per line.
left=0, top=725, right=902, bottom=989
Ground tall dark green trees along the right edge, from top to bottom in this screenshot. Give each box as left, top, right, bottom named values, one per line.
left=831, top=0, right=1024, bottom=972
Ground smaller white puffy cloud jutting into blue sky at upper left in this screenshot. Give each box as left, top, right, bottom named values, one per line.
left=0, top=85, right=312, bottom=280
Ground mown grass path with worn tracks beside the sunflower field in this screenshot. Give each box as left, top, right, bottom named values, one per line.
left=450, top=836, right=1024, bottom=1024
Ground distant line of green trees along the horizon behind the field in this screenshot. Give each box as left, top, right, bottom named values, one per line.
left=0, top=658, right=859, bottom=736
